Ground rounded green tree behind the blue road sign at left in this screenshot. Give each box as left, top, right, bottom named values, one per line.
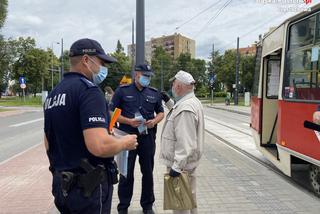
left=14, top=48, right=51, bottom=96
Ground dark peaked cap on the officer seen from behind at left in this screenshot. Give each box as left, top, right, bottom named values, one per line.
left=69, top=38, right=117, bottom=63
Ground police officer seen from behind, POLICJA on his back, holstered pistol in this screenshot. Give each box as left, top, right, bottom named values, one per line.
left=44, top=39, right=138, bottom=214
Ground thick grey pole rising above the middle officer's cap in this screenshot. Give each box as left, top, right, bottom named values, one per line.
left=136, top=0, right=145, bottom=64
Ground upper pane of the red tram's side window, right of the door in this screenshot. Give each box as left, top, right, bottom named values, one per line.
left=289, top=16, right=316, bottom=50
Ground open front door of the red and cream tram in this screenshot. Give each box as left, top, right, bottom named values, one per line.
left=260, top=51, right=281, bottom=156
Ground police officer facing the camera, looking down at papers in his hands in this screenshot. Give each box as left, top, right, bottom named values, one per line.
left=110, top=64, right=164, bottom=213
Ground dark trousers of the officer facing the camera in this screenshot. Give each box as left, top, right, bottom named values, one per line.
left=118, top=129, right=156, bottom=210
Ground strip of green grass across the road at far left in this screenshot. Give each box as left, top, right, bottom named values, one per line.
left=0, top=96, right=42, bottom=107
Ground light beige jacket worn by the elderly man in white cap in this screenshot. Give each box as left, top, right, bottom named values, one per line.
left=160, top=92, right=204, bottom=172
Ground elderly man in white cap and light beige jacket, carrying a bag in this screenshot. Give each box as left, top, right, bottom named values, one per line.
left=160, top=71, right=204, bottom=213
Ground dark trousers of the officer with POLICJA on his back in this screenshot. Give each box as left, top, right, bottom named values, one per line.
left=52, top=175, right=113, bottom=214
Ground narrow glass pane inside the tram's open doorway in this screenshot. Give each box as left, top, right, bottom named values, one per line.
left=267, top=60, right=280, bottom=99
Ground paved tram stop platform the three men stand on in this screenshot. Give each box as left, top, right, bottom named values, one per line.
left=0, top=120, right=320, bottom=214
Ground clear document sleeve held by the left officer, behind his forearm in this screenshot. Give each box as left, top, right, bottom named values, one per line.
left=113, top=128, right=129, bottom=177
